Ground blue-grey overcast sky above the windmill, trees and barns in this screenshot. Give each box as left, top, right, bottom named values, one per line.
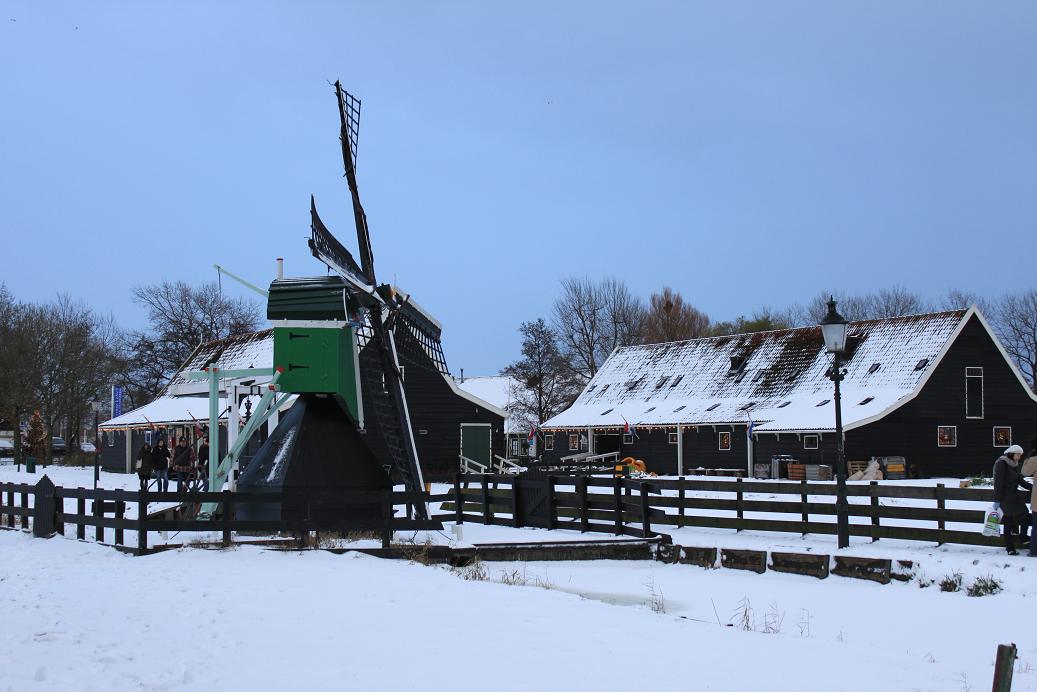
left=0, top=0, right=1037, bottom=375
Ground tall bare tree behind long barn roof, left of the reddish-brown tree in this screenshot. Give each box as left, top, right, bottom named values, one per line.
left=554, top=277, right=644, bottom=380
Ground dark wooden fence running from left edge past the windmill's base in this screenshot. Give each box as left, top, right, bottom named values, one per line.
left=0, top=476, right=443, bottom=555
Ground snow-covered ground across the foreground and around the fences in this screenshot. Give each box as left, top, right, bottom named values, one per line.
left=0, top=466, right=1037, bottom=692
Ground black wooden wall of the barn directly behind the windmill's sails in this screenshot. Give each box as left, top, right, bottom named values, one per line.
left=360, top=330, right=505, bottom=481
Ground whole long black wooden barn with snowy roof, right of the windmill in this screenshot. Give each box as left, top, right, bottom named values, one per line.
left=543, top=308, right=1037, bottom=476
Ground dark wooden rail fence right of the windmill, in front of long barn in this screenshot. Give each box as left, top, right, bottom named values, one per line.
left=439, top=474, right=1001, bottom=546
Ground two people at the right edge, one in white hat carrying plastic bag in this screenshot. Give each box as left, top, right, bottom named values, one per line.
left=993, top=438, right=1037, bottom=557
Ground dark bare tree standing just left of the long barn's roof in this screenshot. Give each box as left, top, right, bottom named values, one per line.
left=501, top=319, right=580, bottom=424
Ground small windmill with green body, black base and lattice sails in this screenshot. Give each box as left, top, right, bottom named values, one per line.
left=231, top=82, right=433, bottom=519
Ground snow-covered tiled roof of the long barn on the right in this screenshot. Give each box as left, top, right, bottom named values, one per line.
left=543, top=308, right=997, bottom=432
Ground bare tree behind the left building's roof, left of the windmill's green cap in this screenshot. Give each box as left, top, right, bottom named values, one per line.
left=124, top=281, right=262, bottom=406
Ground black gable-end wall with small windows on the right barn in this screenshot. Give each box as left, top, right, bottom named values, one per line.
left=844, top=316, right=1037, bottom=476
